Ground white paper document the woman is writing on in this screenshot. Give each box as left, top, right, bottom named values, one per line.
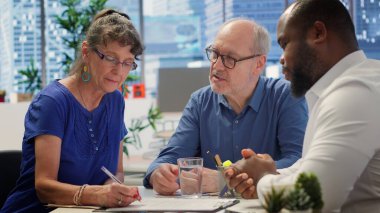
left=106, top=197, right=239, bottom=212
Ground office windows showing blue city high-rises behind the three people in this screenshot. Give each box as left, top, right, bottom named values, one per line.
left=0, top=0, right=380, bottom=101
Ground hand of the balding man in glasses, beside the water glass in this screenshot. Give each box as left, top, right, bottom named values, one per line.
left=149, top=163, right=179, bottom=195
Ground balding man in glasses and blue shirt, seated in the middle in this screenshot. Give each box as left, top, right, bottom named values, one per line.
left=144, top=19, right=307, bottom=194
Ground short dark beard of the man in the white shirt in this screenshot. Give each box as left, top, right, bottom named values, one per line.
left=291, top=42, right=322, bottom=97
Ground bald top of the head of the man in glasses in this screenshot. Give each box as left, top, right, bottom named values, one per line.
left=217, top=19, right=271, bottom=55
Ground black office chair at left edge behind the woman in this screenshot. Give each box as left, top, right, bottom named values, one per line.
left=0, top=150, right=22, bottom=209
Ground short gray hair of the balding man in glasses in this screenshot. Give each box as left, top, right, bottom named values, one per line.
left=220, top=17, right=271, bottom=55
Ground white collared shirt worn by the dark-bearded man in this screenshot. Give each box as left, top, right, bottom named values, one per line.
left=257, top=51, right=380, bottom=212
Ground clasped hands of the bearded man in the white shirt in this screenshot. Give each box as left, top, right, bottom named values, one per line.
left=224, top=149, right=276, bottom=198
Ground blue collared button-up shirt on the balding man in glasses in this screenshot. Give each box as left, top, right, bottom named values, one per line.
left=144, top=77, right=307, bottom=187
